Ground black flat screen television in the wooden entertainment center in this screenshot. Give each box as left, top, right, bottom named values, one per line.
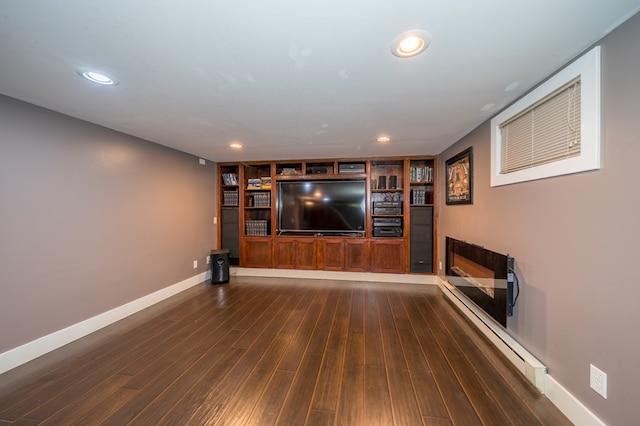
left=277, top=180, right=366, bottom=235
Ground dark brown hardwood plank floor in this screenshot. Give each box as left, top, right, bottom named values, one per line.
left=0, top=277, right=571, bottom=425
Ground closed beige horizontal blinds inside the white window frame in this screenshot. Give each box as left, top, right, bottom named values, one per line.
left=499, top=77, right=580, bottom=173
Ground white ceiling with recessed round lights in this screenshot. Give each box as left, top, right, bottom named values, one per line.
left=0, top=0, right=640, bottom=161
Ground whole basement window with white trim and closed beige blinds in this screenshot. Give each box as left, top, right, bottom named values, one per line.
left=491, top=47, right=600, bottom=186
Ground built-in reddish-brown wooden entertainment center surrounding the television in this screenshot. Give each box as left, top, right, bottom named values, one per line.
left=218, top=156, right=437, bottom=274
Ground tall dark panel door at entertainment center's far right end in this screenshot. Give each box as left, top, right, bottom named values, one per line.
left=409, top=206, right=433, bottom=272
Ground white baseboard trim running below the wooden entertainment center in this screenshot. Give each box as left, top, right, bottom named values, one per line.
left=229, top=267, right=437, bottom=285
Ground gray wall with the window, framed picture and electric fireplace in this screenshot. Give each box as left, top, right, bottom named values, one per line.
left=438, top=11, right=640, bottom=425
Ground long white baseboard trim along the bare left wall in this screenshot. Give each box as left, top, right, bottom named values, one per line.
left=0, top=271, right=211, bottom=374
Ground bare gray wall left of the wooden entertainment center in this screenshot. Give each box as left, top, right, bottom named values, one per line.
left=0, top=96, right=216, bottom=353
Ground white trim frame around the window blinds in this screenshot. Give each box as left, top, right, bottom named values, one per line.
left=491, top=46, right=600, bottom=186
